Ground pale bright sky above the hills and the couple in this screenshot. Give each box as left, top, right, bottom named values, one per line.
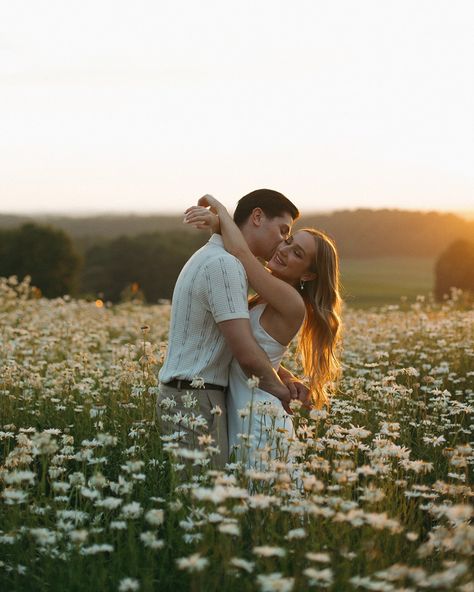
left=0, top=0, right=474, bottom=214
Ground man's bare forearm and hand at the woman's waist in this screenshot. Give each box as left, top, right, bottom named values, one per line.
left=217, top=319, right=291, bottom=411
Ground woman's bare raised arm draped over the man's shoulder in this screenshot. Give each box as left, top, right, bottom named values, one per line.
left=185, top=195, right=305, bottom=328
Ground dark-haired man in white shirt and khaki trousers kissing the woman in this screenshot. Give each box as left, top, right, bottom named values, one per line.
left=158, top=189, right=304, bottom=467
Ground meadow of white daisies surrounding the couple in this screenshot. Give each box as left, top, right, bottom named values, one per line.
left=0, top=278, right=474, bottom=592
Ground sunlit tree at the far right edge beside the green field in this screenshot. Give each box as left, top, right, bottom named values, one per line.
left=435, top=240, right=474, bottom=300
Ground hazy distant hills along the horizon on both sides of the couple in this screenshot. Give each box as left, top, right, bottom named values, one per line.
left=0, top=209, right=474, bottom=258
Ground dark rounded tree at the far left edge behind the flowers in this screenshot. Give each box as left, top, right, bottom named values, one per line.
left=0, top=223, right=81, bottom=298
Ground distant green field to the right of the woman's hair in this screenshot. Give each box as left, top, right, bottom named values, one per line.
left=341, top=257, right=435, bottom=308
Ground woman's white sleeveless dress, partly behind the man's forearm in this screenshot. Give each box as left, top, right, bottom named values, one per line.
left=227, top=303, right=294, bottom=465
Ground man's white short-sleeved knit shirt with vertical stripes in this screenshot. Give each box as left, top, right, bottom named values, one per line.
left=159, top=234, right=249, bottom=386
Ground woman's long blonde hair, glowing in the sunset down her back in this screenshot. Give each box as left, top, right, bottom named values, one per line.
left=298, top=228, right=341, bottom=407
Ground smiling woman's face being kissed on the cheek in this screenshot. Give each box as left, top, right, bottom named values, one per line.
left=267, top=230, right=316, bottom=286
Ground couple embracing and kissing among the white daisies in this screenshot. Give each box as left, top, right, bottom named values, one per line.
left=158, top=189, right=341, bottom=468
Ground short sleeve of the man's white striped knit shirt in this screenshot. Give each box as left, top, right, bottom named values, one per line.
left=203, top=255, right=249, bottom=323
